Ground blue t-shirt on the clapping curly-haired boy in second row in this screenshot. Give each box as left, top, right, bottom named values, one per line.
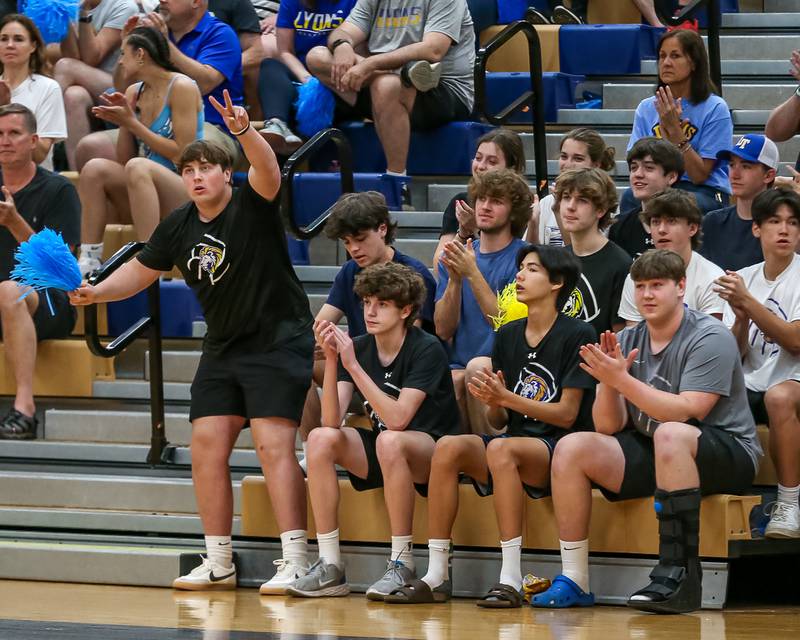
left=436, top=238, right=525, bottom=369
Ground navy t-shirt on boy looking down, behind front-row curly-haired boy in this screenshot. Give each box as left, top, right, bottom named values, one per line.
left=326, top=249, right=436, bottom=338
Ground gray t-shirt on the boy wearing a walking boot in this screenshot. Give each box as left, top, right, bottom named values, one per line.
left=618, top=308, right=762, bottom=469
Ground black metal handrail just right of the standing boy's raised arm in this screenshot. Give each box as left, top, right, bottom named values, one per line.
left=281, top=129, right=355, bottom=240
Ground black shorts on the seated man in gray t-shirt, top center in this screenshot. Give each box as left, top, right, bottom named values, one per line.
left=335, top=84, right=472, bottom=131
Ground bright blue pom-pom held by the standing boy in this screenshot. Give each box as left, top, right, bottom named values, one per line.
left=11, top=229, right=81, bottom=315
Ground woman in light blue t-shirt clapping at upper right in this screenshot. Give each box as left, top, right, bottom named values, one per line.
left=620, top=29, right=733, bottom=213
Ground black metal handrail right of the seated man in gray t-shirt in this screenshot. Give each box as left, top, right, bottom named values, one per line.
left=475, top=20, right=548, bottom=198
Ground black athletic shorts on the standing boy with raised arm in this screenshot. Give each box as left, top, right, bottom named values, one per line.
left=189, top=331, right=314, bottom=422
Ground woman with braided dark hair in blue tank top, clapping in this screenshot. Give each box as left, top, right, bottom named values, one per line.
left=78, top=27, right=204, bottom=275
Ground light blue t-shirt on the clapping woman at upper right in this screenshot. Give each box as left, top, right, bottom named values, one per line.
left=628, top=95, right=733, bottom=193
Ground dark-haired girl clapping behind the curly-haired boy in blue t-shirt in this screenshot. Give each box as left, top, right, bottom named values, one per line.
left=433, top=129, right=525, bottom=267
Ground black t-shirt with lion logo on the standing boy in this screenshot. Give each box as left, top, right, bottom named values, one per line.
left=138, top=182, right=312, bottom=355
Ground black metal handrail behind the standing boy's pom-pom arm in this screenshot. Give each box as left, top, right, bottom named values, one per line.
left=84, top=242, right=169, bottom=466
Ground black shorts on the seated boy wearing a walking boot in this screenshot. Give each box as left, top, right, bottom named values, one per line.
left=598, top=427, right=756, bottom=502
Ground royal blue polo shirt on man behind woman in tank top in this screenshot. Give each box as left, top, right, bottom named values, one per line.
left=169, top=11, right=243, bottom=131
